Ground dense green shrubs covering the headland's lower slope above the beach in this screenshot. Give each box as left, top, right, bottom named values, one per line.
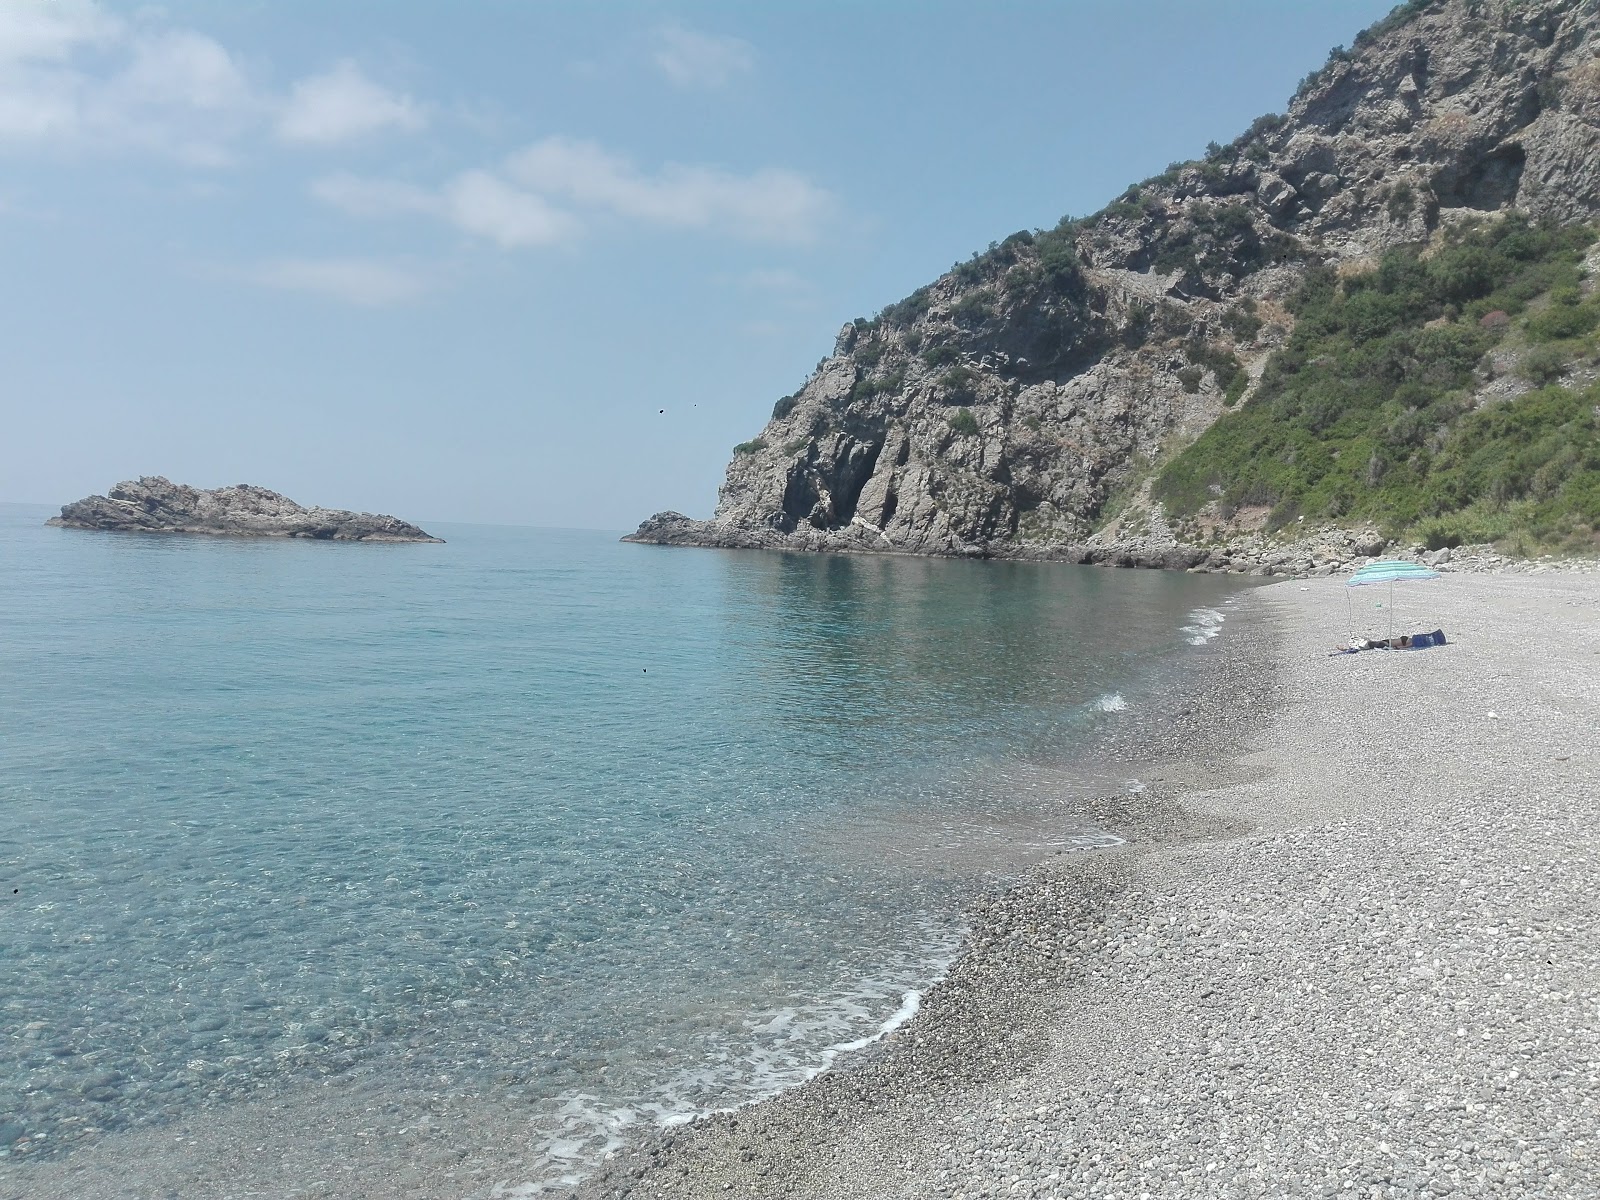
left=1154, top=216, right=1600, bottom=550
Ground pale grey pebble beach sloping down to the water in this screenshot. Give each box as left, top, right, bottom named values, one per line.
left=581, top=571, right=1600, bottom=1200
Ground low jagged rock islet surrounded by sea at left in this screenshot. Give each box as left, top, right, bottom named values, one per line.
left=45, top=475, right=443, bottom=542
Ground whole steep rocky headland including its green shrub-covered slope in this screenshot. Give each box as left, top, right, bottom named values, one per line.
left=629, top=0, right=1600, bottom=570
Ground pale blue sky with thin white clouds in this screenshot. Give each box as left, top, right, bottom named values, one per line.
left=0, top=0, right=1392, bottom=530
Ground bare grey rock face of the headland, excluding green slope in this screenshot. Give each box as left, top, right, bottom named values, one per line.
left=630, top=0, right=1600, bottom=565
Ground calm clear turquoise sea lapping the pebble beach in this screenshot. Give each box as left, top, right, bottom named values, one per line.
left=0, top=507, right=1237, bottom=1189
